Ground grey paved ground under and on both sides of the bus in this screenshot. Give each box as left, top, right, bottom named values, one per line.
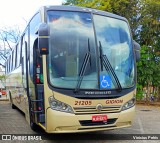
left=0, top=101, right=160, bottom=143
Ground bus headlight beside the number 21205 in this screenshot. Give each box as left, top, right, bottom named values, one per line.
left=49, top=96, right=73, bottom=113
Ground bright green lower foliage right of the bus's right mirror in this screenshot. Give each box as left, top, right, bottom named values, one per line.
left=137, top=45, right=160, bottom=99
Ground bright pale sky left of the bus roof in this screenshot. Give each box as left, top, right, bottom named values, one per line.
left=0, top=0, right=64, bottom=28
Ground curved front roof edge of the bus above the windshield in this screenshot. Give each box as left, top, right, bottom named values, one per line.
left=41, top=5, right=127, bottom=21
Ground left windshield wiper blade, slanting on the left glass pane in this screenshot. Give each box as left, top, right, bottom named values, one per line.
left=74, top=52, right=91, bottom=93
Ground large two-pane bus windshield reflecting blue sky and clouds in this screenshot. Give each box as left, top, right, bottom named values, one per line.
left=47, top=11, right=134, bottom=90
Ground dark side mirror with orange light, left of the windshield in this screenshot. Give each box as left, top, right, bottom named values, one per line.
left=38, top=23, right=49, bottom=55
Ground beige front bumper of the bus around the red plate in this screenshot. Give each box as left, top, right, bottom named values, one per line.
left=46, top=106, right=135, bottom=133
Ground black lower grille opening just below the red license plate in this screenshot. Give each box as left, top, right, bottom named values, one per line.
left=79, top=118, right=117, bottom=126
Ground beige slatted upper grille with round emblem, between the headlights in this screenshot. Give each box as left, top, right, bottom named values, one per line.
left=73, top=106, right=121, bottom=115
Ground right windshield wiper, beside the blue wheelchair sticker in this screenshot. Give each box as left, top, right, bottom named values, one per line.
left=99, top=41, right=122, bottom=92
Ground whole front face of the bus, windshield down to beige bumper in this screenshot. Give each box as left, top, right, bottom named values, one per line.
left=43, top=10, right=136, bottom=133
